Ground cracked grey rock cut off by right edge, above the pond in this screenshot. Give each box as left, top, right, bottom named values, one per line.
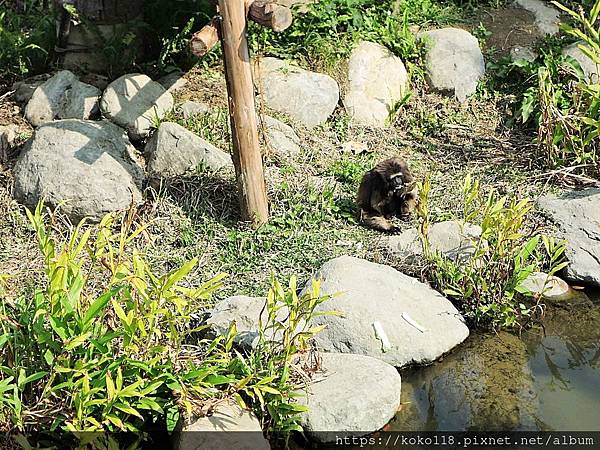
left=538, top=188, right=600, bottom=286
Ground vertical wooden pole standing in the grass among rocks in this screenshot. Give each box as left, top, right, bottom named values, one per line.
left=219, top=0, right=269, bottom=226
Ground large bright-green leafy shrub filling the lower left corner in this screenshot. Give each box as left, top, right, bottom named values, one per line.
left=0, top=204, right=325, bottom=447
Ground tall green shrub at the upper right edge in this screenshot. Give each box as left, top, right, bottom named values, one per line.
left=506, top=0, right=600, bottom=177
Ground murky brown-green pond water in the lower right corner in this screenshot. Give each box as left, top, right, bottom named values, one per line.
left=390, top=294, right=600, bottom=431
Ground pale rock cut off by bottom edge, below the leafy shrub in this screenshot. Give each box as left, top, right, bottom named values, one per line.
left=173, top=402, right=271, bottom=450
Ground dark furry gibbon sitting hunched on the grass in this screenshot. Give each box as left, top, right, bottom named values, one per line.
left=356, top=158, right=417, bottom=231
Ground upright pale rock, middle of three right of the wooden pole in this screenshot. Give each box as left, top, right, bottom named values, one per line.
left=344, top=41, right=408, bottom=128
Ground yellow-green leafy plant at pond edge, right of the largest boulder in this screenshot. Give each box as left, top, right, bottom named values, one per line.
left=417, top=176, right=567, bottom=328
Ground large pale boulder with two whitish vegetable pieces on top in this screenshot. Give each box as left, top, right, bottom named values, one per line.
left=303, top=256, right=469, bottom=368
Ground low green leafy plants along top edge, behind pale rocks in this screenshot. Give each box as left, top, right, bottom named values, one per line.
left=250, top=0, right=456, bottom=72
